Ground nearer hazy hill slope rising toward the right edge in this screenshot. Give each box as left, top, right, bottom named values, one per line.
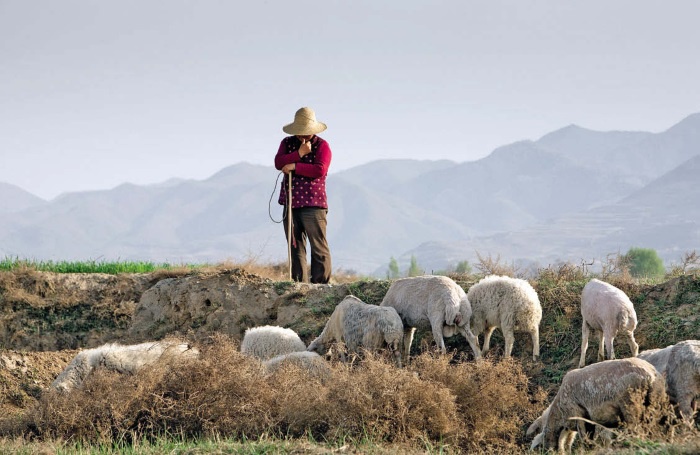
left=396, top=155, right=700, bottom=273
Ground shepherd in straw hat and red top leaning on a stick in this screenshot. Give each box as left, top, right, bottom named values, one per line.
left=275, top=107, right=332, bottom=283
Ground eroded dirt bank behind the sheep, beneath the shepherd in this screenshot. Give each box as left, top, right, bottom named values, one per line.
left=0, top=268, right=700, bottom=450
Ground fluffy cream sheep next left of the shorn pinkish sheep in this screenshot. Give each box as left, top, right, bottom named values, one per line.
left=467, top=275, right=542, bottom=360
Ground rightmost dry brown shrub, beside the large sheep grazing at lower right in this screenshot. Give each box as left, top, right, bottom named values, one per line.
left=411, top=353, right=532, bottom=452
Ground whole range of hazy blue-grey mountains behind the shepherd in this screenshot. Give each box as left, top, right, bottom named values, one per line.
left=0, top=114, right=700, bottom=276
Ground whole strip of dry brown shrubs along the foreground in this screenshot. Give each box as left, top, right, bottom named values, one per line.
left=15, top=335, right=529, bottom=451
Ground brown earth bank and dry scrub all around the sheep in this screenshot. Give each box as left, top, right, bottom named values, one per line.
left=0, top=261, right=700, bottom=453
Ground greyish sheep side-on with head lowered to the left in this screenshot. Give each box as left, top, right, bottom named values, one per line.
left=307, top=295, right=403, bottom=368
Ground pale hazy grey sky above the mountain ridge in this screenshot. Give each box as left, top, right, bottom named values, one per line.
left=0, top=0, right=700, bottom=199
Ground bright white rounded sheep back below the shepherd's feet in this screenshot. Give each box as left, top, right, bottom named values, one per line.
left=241, top=325, right=306, bottom=360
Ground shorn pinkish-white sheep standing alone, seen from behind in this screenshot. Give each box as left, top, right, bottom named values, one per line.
left=578, top=278, right=639, bottom=368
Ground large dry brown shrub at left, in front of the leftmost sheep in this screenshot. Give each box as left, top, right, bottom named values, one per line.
left=33, top=336, right=274, bottom=442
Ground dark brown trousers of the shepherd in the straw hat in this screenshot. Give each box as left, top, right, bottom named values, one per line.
left=283, top=207, right=331, bottom=283
